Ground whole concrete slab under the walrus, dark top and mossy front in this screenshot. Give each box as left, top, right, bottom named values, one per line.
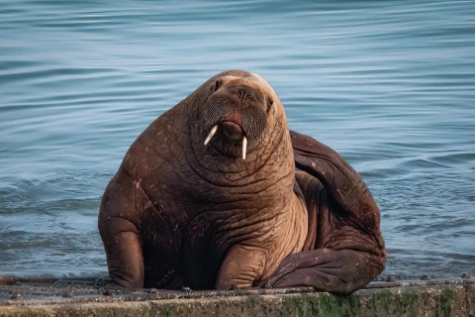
left=0, top=278, right=475, bottom=317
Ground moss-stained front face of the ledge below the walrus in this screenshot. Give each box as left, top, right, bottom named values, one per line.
left=0, top=280, right=475, bottom=317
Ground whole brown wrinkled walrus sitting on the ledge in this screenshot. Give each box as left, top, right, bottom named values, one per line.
left=99, top=71, right=386, bottom=294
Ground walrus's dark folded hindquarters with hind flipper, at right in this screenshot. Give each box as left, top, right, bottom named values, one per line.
left=269, top=131, right=386, bottom=294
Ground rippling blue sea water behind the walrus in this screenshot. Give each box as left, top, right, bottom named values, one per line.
left=0, top=0, right=475, bottom=277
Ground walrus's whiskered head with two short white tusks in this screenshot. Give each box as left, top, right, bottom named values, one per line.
left=190, top=71, right=286, bottom=161
